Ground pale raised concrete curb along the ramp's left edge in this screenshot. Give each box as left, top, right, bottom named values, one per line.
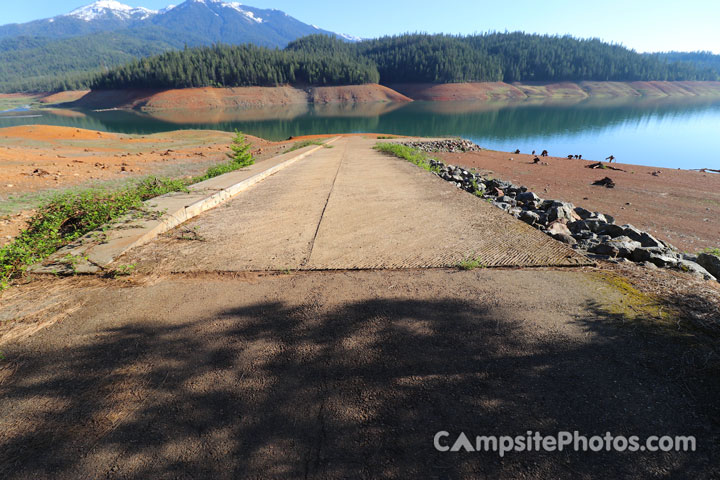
left=28, top=137, right=342, bottom=274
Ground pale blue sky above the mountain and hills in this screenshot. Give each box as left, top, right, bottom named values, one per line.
left=5, top=0, right=720, bottom=53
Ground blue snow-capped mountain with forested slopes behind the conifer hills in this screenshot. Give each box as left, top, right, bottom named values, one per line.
left=0, top=0, right=355, bottom=89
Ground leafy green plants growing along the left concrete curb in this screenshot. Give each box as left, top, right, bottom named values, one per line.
left=0, top=132, right=254, bottom=290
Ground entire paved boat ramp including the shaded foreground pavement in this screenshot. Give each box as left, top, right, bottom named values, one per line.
left=5, top=136, right=720, bottom=480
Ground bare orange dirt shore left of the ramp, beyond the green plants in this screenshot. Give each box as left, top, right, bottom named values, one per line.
left=0, top=125, right=298, bottom=246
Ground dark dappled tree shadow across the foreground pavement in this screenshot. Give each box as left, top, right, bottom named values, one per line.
left=0, top=298, right=720, bottom=478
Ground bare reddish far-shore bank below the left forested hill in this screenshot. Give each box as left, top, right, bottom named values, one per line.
left=71, top=85, right=411, bottom=111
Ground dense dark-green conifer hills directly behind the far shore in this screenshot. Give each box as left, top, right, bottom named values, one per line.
left=92, top=33, right=720, bottom=89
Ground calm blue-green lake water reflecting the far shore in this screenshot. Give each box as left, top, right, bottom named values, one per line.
left=0, top=98, right=720, bottom=169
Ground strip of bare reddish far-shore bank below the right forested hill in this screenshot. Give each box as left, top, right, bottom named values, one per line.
left=391, top=82, right=720, bottom=102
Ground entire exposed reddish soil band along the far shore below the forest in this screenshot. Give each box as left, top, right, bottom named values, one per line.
left=50, top=82, right=720, bottom=111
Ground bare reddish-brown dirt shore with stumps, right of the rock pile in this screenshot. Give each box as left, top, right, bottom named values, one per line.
left=433, top=150, right=720, bottom=252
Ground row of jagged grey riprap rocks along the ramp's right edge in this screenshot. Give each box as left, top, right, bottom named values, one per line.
left=429, top=158, right=720, bottom=280
